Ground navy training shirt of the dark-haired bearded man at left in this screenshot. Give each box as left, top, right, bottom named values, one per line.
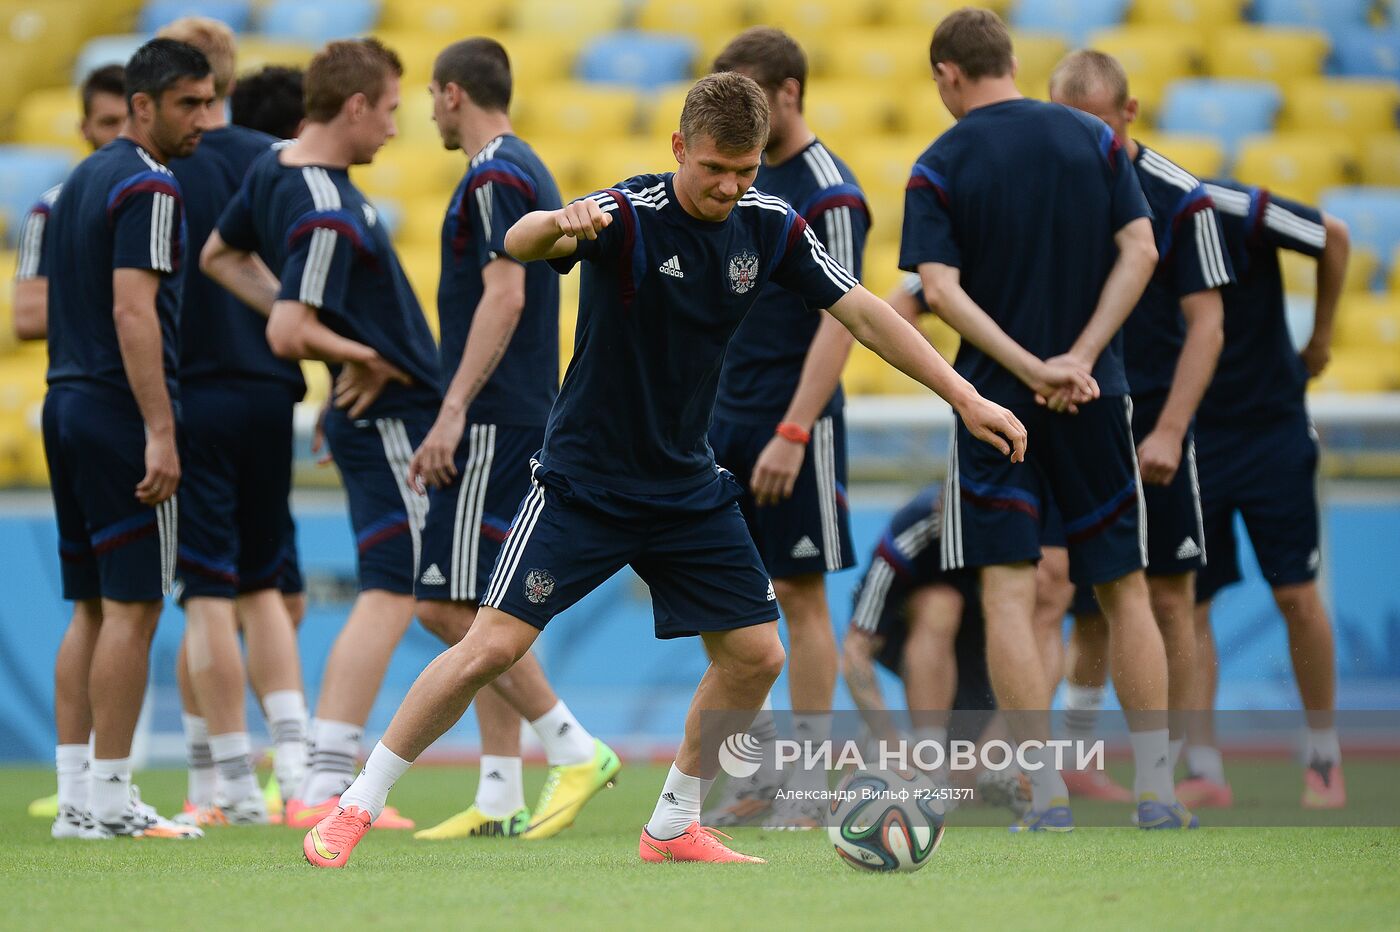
left=39, top=136, right=186, bottom=399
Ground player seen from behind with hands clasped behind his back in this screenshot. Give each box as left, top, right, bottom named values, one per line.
left=900, top=8, right=1193, bottom=831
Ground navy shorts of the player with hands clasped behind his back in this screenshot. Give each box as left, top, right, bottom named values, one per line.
left=942, top=396, right=1147, bottom=585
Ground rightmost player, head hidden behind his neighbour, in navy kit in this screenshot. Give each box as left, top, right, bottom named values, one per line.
left=1180, top=181, right=1351, bottom=809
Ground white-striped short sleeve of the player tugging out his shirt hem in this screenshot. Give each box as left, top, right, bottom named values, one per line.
left=277, top=209, right=365, bottom=313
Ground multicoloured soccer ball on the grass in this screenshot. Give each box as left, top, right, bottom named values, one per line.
left=826, top=770, right=944, bottom=873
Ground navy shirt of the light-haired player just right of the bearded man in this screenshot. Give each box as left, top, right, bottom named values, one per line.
left=171, top=126, right=307, bottom=399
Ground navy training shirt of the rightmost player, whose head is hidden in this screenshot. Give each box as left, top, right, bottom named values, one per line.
left=1196, top=181, right=1327, bottom=427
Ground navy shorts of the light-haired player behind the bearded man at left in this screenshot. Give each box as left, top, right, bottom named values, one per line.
left=178, top=379, right=297, bottom=599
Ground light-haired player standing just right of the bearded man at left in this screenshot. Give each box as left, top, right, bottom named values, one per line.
left=160, top=17, right=307, bottom=824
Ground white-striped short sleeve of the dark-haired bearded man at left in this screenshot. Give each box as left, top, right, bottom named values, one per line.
left=106, top=171, right=185, bottom=274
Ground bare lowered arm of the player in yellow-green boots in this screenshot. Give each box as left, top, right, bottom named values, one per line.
left=409, top=257, right=525, bottom=491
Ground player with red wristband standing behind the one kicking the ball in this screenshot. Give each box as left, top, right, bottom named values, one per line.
left=705, top=27, right=869, bottom=828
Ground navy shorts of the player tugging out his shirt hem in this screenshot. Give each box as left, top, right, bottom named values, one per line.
left=325, top=409, right=435, bottom=595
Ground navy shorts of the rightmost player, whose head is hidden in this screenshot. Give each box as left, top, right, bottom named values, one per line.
left=1196, top=411, right=1322, bottom=602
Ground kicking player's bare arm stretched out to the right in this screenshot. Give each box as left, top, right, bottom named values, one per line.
left=830, top=285, right=1026, bottom=463
